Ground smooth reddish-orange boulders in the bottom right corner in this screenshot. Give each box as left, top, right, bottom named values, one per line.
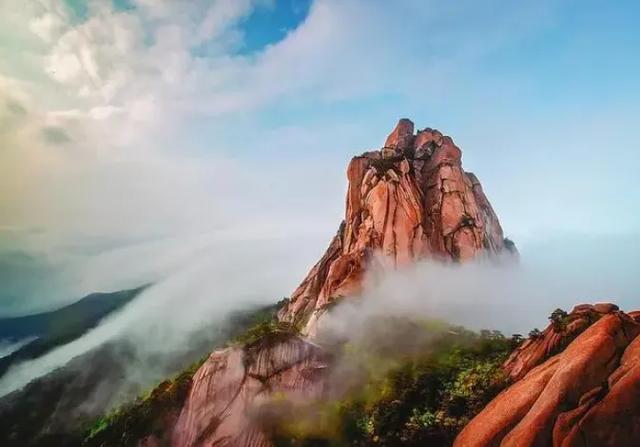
left=454, top=304, right=640, bottom=447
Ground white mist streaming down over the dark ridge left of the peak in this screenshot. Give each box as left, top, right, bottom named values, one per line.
left=0, top=235, right=322, bottom=396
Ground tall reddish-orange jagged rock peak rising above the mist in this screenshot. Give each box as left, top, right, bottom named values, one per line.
left=279, top=119, right=511, bottom=334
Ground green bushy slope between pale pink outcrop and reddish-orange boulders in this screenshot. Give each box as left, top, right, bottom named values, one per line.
left=268, top=318, right=522, bottom=446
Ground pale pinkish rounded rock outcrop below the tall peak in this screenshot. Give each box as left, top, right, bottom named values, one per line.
left=172, top=334, right=328, bottom=447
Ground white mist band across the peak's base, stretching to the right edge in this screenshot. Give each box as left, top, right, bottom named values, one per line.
left=319, top=238, right=640, bottom=339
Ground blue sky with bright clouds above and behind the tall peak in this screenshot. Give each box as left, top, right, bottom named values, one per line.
left=0, top=0, right=640, bottom=316
